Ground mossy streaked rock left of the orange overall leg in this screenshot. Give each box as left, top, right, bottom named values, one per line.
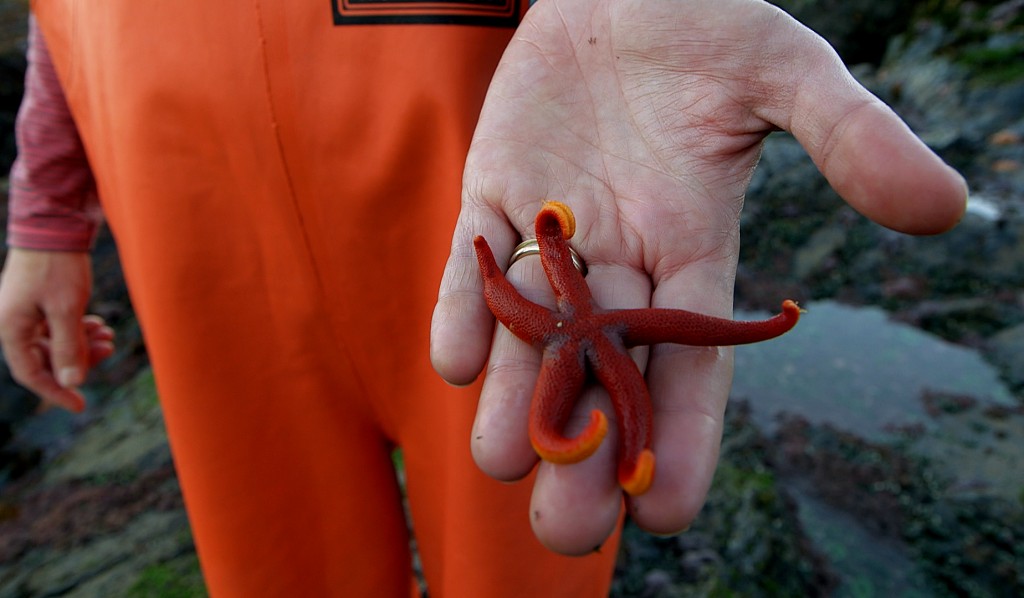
left=0, top=370, right=199, bottom=598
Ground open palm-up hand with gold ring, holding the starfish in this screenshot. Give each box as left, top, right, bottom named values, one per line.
left=431, top=0, right=967, bottom=554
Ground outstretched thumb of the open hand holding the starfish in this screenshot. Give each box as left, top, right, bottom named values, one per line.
left=769, top=26, right=967, bottom=234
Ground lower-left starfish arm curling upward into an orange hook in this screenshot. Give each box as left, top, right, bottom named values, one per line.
left=529, top=341, right=608, bottom=464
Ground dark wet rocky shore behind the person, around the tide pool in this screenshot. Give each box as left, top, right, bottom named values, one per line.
left=0, top=0, right=1024, bottom=598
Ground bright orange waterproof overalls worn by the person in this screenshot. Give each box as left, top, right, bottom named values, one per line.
left=34, top=0, right=615, bottom=598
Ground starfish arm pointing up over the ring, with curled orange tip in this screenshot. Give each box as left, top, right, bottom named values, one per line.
left=535, top=202, right=592, bottom=314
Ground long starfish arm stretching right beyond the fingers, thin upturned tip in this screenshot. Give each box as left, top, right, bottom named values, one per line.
left=610, top=299, right=801, bottom=347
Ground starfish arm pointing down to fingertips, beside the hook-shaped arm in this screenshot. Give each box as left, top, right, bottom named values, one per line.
left=590, top=339, right=654, bottom=496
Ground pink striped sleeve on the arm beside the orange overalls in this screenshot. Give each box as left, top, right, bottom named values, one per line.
left=7, top=18, right=102, bottom=251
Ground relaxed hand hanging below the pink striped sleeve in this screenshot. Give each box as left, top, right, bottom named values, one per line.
left=0, top=249, right=114, bottom=413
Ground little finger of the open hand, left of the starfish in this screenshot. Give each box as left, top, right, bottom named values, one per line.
left=430, top=207, right=518, bottom=385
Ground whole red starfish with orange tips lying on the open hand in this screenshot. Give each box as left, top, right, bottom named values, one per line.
left=473, top=202, right=800, bottom=496
